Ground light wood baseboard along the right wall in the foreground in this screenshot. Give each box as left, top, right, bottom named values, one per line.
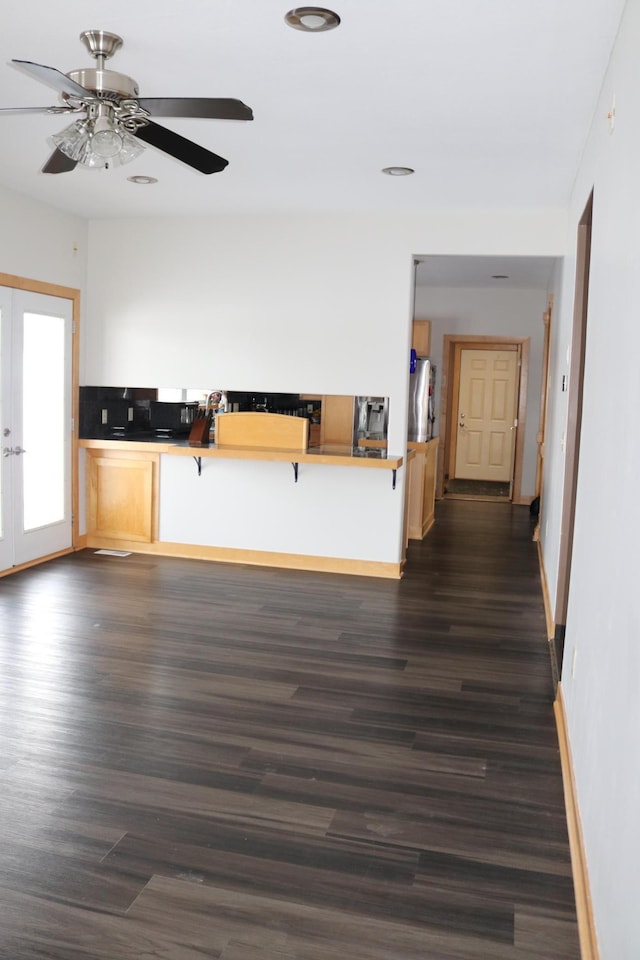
left=553, top=683, right=600, bottom=960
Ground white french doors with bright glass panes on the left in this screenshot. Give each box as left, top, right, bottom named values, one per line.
left=0, top=286, right=73, bottom=571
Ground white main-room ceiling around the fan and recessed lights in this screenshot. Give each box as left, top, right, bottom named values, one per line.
left=0, top=0, right=624, bottom=221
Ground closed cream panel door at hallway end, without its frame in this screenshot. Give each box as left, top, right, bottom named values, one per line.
left=455, top=350, right=518, bottom=482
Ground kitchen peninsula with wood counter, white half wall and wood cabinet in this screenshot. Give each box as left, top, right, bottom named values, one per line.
left=79, top=413, right=406, bottom=578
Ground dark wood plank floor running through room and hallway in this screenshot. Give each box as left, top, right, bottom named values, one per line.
left=0, top=501, right=579, bottom=960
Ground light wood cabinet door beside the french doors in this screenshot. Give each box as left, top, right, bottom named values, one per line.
left=87, top=450, right=159, bottom=547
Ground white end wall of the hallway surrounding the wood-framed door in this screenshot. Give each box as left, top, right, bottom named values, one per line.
left=415, top=287, right=548, bottom=498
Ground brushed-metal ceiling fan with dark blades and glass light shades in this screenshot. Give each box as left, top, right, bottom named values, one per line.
left=0, top=30, right=253, bottom=174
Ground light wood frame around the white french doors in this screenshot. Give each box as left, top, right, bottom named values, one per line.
left=0, top=273, right=80, bottom=577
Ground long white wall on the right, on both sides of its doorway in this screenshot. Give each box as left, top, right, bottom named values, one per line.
left=543, top=0, right=640, bottom=960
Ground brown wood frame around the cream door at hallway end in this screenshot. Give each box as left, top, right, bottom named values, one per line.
left=436, top=334, right=530, bottom=504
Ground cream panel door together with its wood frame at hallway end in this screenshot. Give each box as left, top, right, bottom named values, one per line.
left=436, top=335, right=529, bottom=503
